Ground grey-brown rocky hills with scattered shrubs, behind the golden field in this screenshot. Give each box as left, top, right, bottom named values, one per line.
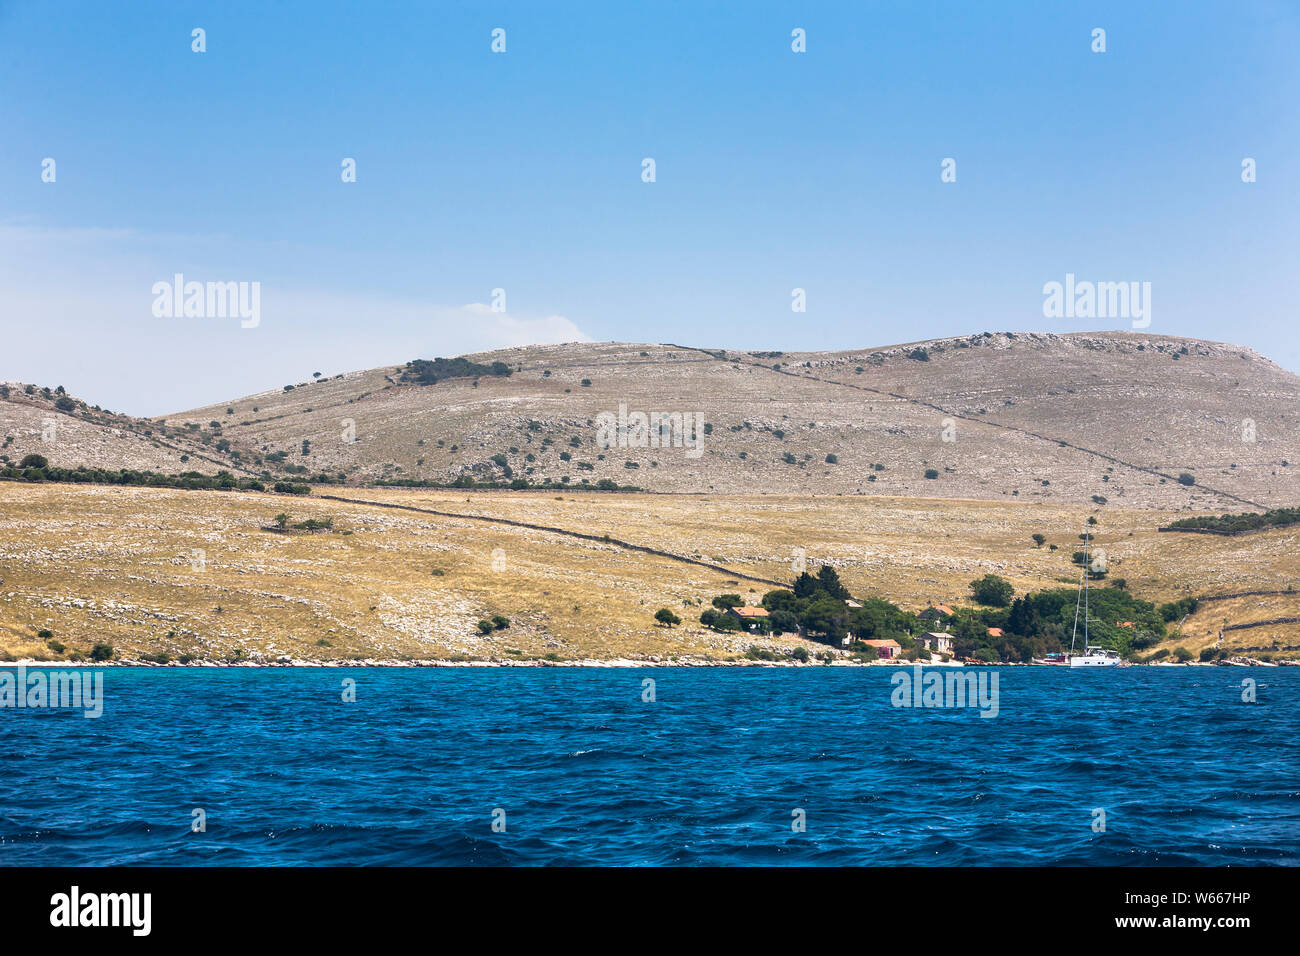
left=0, top=332, right=1300, bottom=512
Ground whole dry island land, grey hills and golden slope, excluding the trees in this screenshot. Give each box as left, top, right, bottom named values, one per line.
left=0, top=332, right=1300, bottom=663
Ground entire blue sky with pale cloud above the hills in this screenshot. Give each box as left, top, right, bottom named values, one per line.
left=0, top=0, right=1300, bottom=415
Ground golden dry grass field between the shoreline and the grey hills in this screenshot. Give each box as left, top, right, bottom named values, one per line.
left=0, top=483, right=1300, bottom=662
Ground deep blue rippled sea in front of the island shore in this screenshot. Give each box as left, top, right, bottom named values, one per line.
left=0, top=667, right=1300, bottom=865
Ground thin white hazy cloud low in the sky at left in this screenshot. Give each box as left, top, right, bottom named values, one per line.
left=0, top=226, right=590, bottom=415
